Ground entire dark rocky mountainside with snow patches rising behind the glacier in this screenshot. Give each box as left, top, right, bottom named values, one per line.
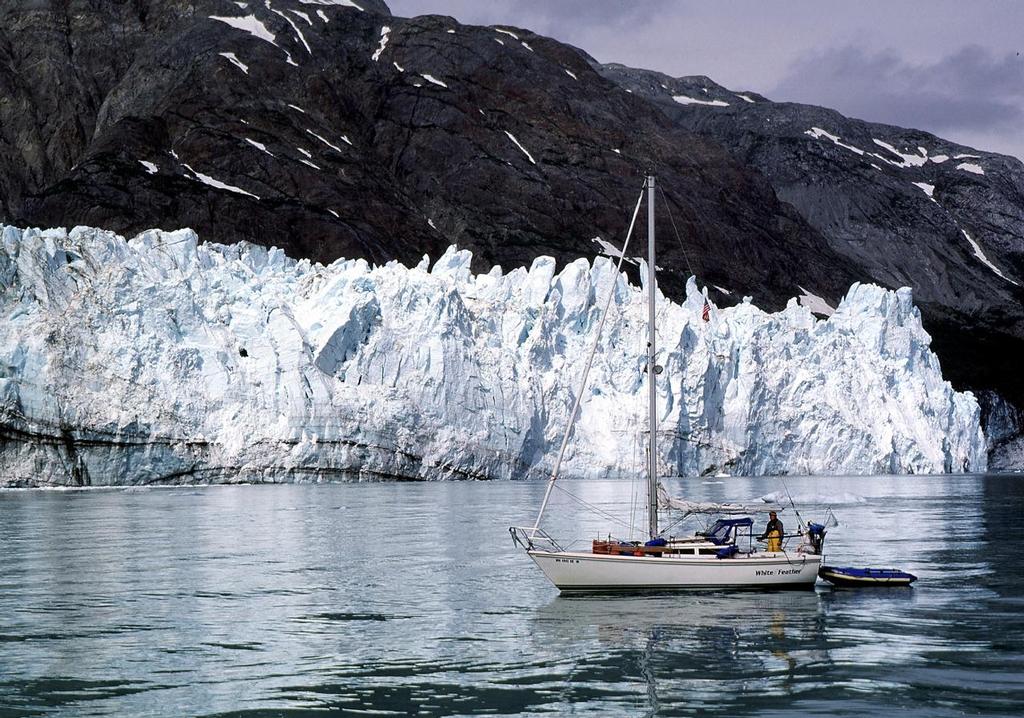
left=0, top=0, right=1024, bottom=419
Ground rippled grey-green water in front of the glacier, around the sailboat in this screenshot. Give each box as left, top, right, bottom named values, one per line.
left=0, top=477, right=1024, bottom=717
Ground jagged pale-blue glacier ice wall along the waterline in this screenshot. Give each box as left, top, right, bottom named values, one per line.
left=0, top=226, right=986, bottom=485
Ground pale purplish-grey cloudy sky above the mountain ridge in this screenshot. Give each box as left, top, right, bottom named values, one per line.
left=387, top=0, right=1024, bottom=159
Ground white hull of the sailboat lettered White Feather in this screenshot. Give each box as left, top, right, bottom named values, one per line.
left=527, top=550, right=821, bottom=592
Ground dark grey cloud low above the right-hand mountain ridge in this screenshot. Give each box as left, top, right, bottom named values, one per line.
left=770, top=45, right=1024, bottom=134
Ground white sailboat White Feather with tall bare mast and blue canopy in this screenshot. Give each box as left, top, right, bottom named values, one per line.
left=509, top=175, right=825, bottom=593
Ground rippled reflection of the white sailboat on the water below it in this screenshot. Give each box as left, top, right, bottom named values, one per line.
left=531, top=592, right=835, bottom=714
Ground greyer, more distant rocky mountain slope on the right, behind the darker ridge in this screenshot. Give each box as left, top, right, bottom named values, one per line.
left=597, top=65, right=1024, bottom=409
